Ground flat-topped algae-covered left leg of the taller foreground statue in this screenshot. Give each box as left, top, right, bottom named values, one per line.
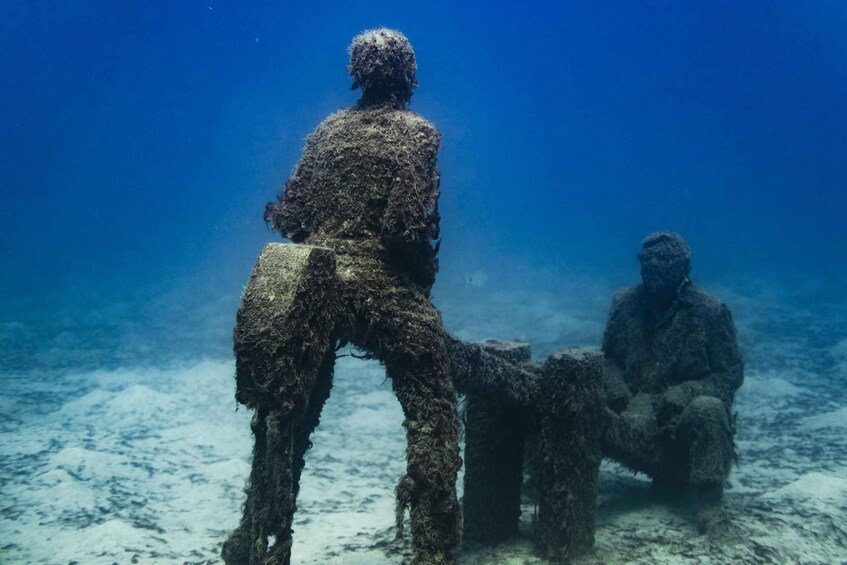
left=227, top=244, right=338, bottom=565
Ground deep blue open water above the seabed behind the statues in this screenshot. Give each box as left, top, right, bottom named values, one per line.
left=0, top=0, right=847, bottom=368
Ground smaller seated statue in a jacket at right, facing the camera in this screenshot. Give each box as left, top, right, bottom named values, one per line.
left=602, top=232, right=744, bottom=532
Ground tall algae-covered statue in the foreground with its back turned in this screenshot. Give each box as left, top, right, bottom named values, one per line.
left=223, top=29, right=460, bottom=564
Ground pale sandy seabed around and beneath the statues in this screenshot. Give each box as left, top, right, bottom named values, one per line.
left=0, top=282, right=847, bottom=564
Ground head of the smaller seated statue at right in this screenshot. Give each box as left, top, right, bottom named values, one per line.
left=638, top=232, right=691, bottom=296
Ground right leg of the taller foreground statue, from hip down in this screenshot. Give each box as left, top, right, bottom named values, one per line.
left=338, top=254, right=462, bottom=564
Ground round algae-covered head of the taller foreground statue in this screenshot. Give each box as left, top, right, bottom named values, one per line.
left=347, top=28, right=418, bottom=107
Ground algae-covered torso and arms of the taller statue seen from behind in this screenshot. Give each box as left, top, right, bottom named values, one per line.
left=272, top=106, right=440, bottom=288
